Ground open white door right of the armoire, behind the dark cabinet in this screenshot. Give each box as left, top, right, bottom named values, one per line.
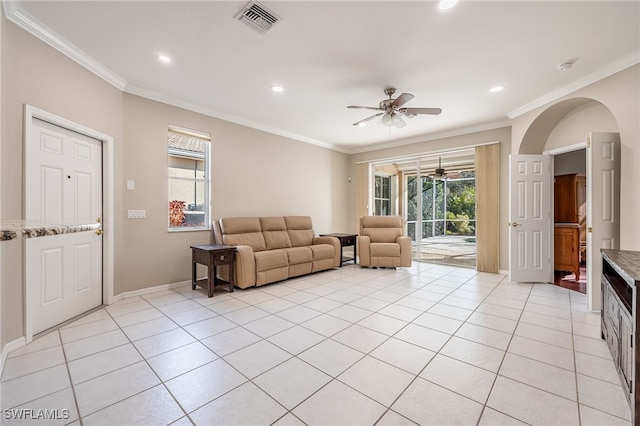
left=587, top=133, right=620, bottom=310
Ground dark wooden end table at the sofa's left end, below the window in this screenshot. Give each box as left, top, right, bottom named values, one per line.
left=191, top=244, right=236, bottom=297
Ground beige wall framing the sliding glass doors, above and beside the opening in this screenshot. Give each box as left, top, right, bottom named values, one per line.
left=349, top=127, right=511, bottom=270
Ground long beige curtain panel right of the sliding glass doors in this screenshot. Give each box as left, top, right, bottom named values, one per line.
left=476, top=143, right=500, bottom=272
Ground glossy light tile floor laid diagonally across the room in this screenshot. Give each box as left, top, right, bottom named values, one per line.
left=0, top=263, right=630, bottom=425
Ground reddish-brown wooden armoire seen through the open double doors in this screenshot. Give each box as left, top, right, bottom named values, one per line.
left=553, top=173, right=587, bottom=280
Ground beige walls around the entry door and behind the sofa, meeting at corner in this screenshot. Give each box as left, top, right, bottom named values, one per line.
left=0, top=20, right=351, bottom=347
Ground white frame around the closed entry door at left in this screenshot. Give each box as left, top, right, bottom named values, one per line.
left=23, top=104, right=115, bottom=343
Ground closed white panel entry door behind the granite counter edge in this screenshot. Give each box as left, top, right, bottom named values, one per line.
left=25, top=118, right=102, bottom=334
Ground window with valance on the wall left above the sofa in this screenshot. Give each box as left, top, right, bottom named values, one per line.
left=167, top=126, right=211, bottom=231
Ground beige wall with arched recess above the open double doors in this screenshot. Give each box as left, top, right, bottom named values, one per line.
left=512, top=65, right=640, bottom=250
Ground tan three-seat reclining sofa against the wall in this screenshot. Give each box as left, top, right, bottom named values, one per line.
left=214, top=216, right=340, bottom=288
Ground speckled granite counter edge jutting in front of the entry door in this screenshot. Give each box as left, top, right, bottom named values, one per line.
left=0, top=220, right=102, bottom=241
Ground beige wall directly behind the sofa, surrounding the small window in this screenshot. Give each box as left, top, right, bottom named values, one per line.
left=116, top=94, right=349, bottom=293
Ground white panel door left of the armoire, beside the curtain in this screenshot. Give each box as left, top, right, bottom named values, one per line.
left=509, top=155, right=552, bottom=282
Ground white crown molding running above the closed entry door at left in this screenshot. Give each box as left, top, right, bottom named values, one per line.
left=3, top=0, right=127, bottom=90
